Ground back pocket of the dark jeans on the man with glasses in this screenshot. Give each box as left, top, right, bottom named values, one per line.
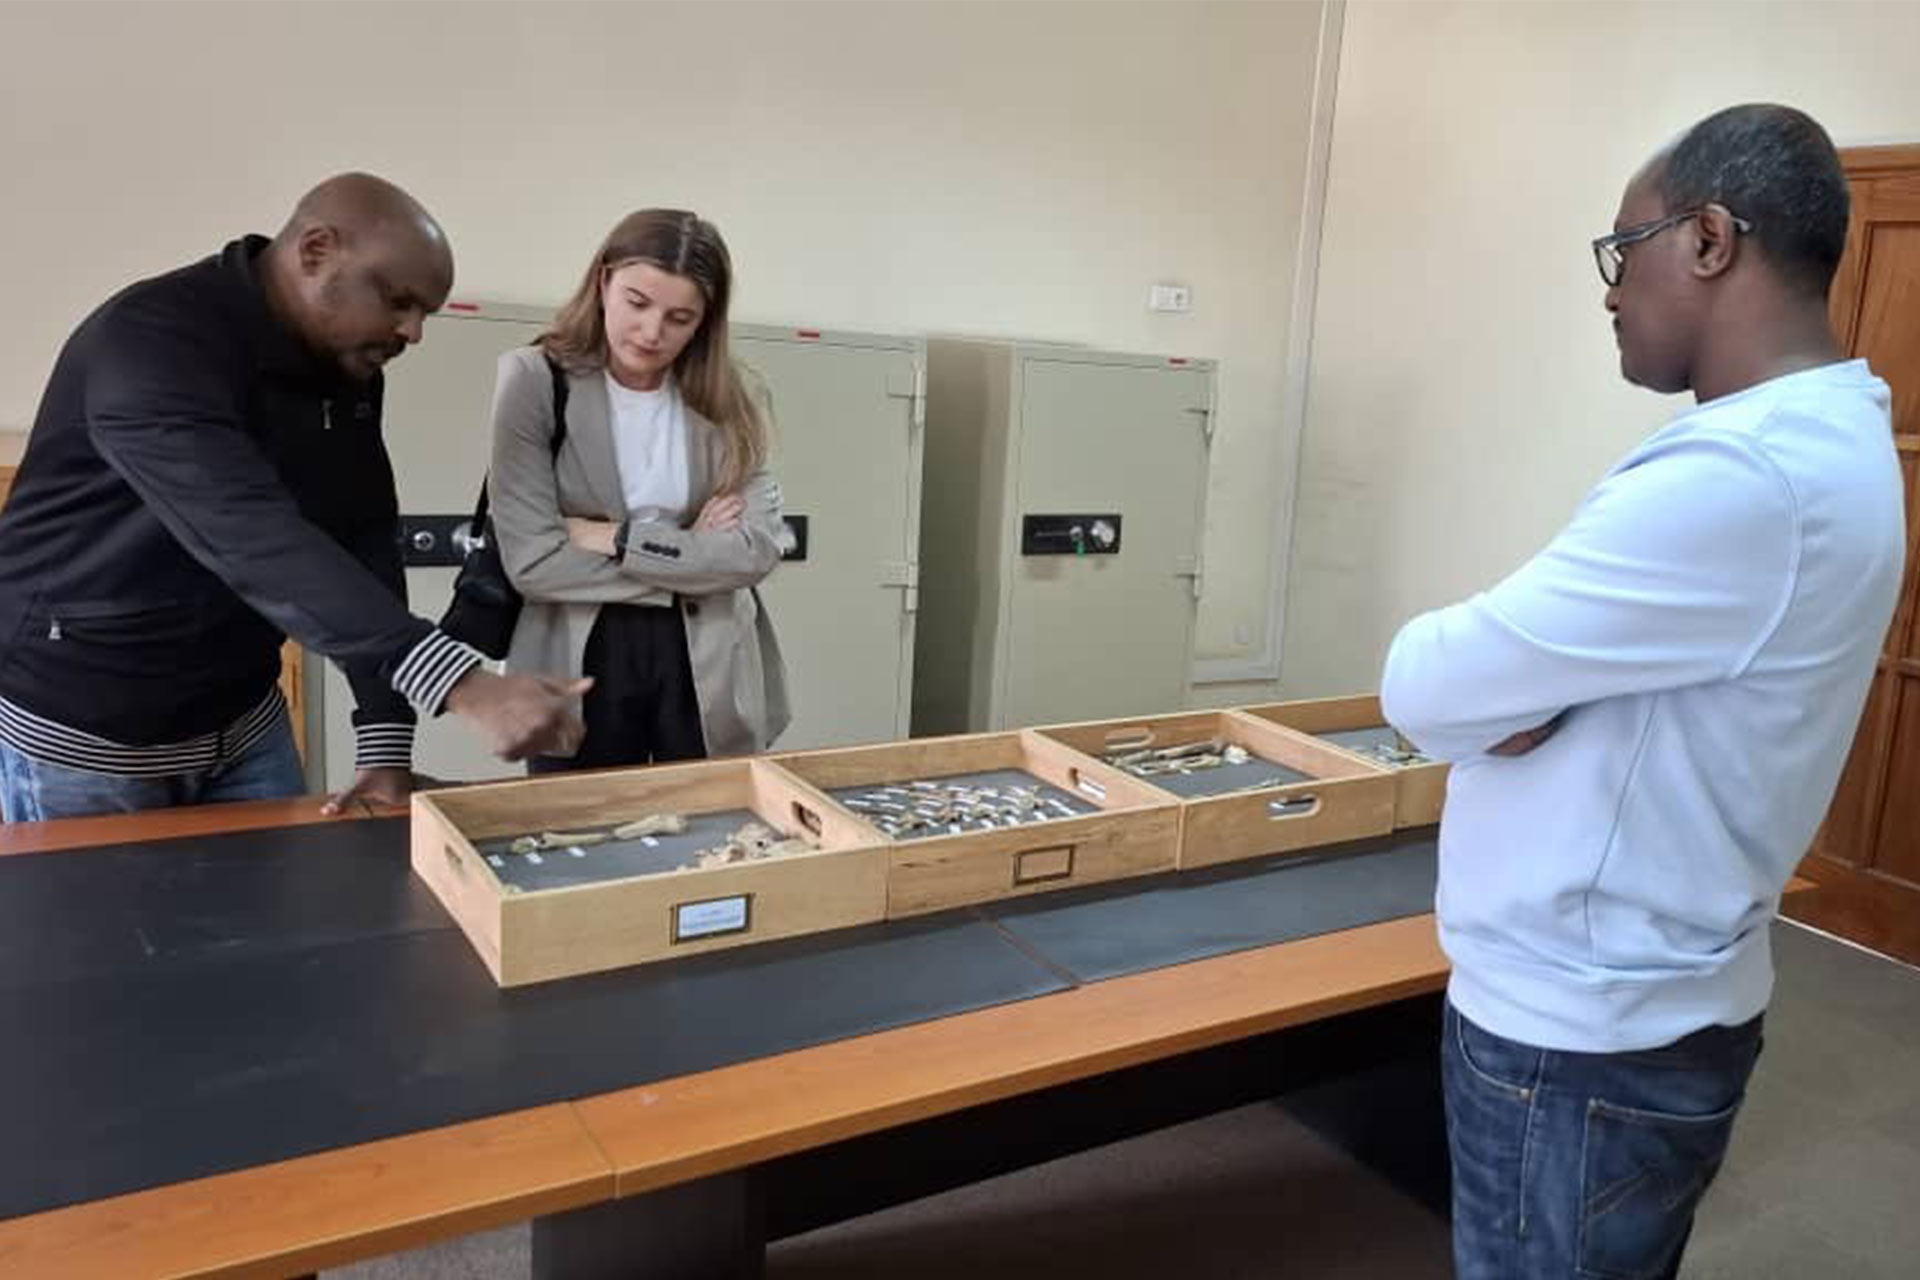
left=1580, top=1096, right=1741, bottom=1280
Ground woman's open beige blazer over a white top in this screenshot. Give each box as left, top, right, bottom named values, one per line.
left=488, top=347, right=791, bottom=756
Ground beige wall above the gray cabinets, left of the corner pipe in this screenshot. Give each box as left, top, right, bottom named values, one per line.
left=0, top=0, right=1321, bottom=675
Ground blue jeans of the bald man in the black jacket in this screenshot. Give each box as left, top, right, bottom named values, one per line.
left=0, top=716, right=307, bottom=821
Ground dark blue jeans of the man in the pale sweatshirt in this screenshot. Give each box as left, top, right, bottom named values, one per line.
left=1440, top=1002, right=1761, bottom=1280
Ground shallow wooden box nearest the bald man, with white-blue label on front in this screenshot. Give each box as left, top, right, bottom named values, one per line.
left=413, top=760, right=887, bottom=986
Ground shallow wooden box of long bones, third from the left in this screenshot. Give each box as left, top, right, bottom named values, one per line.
left=1041, top=712, right=1394, bottom=869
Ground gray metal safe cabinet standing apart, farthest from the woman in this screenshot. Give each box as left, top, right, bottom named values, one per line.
left=912, top=340, right=1215, bottom=735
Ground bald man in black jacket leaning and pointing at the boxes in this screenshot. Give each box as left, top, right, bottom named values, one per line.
left=0, top=175, right=584, bottom=821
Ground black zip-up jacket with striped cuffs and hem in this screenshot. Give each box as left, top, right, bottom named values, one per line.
left=0, top=236, right=472, bottom=764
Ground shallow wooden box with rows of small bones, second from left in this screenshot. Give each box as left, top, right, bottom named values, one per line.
left=774, top=729, right=1181, bottom=917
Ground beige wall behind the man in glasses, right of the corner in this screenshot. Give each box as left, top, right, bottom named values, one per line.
left=1281, top=0, right=1920, bottom=695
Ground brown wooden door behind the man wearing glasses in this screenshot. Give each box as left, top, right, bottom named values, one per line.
left=1788, top=146, right=1920, bottom=963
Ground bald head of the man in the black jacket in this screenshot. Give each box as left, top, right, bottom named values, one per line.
left=267, top=173, right=453, bottom=380
